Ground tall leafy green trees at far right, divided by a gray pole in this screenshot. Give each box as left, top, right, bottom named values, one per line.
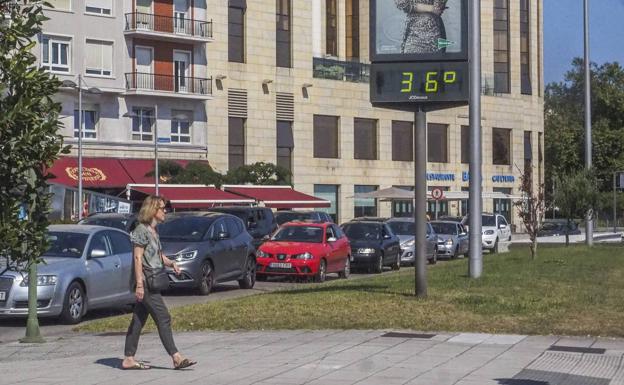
left=544, top=58, right=624, bottom=192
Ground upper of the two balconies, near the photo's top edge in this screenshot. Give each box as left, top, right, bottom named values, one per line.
left=124, top=12, right=213, bottom=43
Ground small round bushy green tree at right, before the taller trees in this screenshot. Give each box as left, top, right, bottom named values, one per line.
left=555, top=169, right=599, bottom=246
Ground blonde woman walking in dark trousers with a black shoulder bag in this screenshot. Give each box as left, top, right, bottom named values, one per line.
left=121, top=196, right=197, bottom=370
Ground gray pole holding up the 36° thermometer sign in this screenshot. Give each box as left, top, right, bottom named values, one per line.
left=414, top=106, right=427, bottom=298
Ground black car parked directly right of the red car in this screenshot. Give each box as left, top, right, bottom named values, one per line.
left=341, top=221, right=401, bottom=273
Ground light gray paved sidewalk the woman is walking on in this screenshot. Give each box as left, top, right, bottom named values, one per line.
left=0, top=330, right=624, bottom=385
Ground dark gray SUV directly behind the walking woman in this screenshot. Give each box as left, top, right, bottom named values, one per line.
left=158, top=212, right=256, bottom=295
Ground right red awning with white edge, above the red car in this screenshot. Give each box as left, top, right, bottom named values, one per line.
left=223, top=185, right=331, bottom=209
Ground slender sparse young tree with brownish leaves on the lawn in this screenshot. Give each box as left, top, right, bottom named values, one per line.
left=515, top=167, right=545, bottom=259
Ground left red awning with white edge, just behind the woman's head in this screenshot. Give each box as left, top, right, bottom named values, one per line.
left=128, top=184, right=254, bottom=209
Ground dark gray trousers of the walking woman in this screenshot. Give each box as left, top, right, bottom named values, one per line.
left=124, top=290, right=178, bottom=357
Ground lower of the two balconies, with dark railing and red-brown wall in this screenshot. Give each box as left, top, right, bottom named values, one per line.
left=126, top=72, right=212, bottom=100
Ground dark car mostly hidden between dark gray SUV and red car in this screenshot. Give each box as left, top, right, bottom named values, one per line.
left=210, top=206, right=277, bottom=248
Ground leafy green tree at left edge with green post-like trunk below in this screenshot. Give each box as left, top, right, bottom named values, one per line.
left=0, top=0, right=66, bottom=342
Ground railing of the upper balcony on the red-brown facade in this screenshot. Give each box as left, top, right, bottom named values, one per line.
left=126, top=12, right=212, bottom=38
